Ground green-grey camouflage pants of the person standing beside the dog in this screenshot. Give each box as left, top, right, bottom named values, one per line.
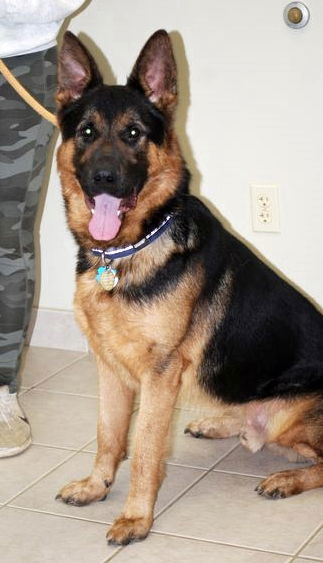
left=0, top=47, right=56, bottom=392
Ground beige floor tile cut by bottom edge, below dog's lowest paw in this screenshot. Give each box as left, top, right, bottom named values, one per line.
left=113, top=534, right=286, bottom=563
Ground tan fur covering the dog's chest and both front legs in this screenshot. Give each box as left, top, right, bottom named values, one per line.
left=60, top=262, right=191, bottom=541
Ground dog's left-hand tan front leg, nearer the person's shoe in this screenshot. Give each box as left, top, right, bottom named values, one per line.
left=56, top=360, right=134, bottom=506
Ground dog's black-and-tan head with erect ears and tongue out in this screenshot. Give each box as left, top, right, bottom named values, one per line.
left=57, top=30, right=183, bottom=244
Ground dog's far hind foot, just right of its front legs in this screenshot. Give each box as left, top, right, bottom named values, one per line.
left=184, top=405, right=245, bottom=438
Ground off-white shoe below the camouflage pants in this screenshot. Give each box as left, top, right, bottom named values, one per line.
left=0, top=385, right=31, bottom=457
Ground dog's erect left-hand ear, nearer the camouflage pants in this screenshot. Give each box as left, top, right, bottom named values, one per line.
left=56, top=31, right=103, bottom=107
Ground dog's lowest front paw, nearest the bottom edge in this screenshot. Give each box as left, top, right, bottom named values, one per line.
left=107, top=516, right=153, bottom=545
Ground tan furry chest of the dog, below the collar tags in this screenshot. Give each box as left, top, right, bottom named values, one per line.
left=75, top=273, right=195, bottom=379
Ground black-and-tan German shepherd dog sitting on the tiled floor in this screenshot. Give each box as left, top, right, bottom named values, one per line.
left=57, top=30, right=323, bottom=545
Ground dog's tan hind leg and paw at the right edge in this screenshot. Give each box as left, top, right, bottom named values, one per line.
left=256, top=396, right=323, bottom=499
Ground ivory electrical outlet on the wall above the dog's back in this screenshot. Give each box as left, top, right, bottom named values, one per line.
left=250, top=184, right=280, bottom=233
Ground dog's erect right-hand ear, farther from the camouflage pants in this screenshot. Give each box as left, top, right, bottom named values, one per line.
left=127, top=29, right=177, bottom=113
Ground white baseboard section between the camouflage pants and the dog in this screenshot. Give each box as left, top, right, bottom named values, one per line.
left=27, top=309, right=88, bottom=352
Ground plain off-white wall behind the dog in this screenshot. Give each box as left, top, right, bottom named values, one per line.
left=34, top=0, right=323, bottom=328
